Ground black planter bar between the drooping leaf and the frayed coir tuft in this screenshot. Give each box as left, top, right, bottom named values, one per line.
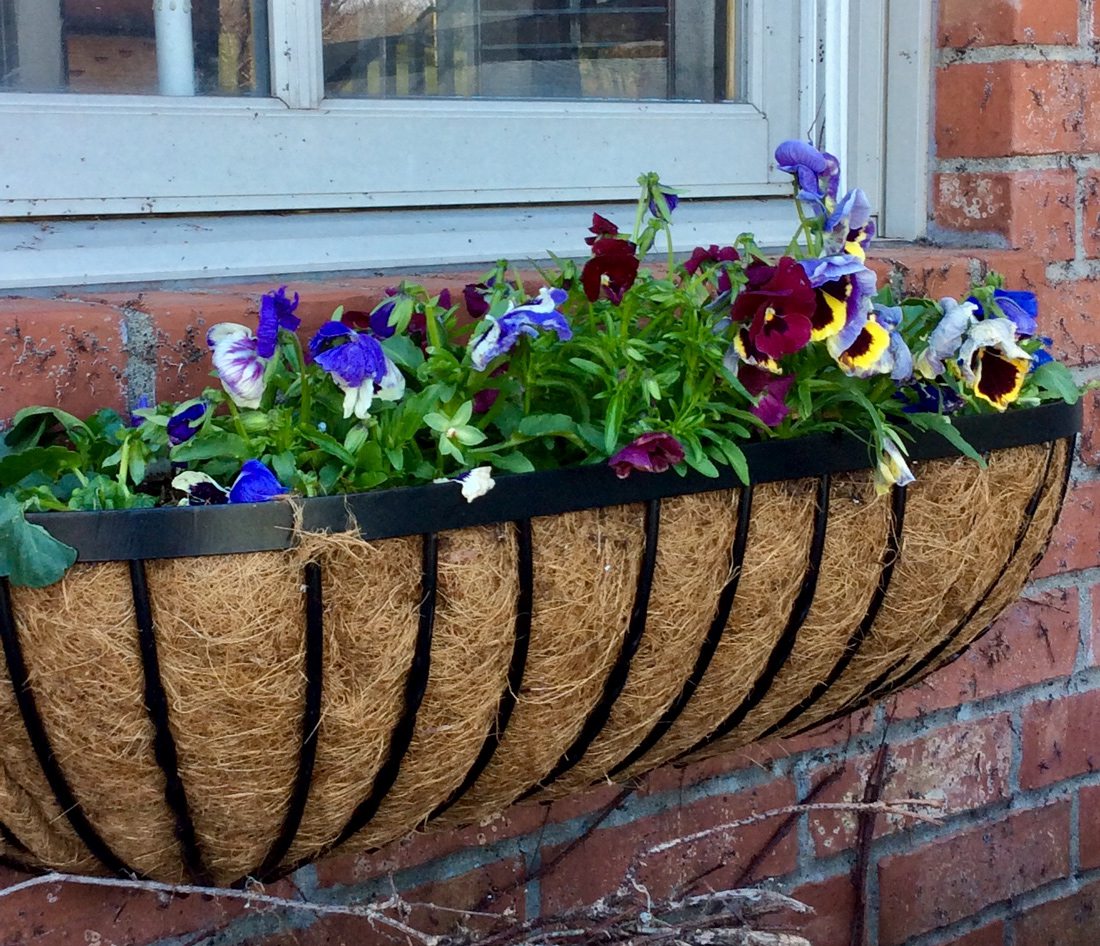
left=130, top=560, right=210, bottom=884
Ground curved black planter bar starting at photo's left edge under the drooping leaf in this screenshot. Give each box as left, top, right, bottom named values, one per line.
left=0, top=579, right=141, bottom=877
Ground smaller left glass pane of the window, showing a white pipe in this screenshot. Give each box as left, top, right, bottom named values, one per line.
left=0, top=0, right=271, bottom=96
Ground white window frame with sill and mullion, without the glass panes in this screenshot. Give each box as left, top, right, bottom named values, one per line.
left=0, top=0, right=931, bottom=288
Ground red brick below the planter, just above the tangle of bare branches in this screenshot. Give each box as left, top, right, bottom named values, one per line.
left=541, top=781, right=798, bottom=913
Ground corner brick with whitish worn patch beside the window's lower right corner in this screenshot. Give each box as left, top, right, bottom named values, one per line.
left=933, top=169, right=1077, bottom=262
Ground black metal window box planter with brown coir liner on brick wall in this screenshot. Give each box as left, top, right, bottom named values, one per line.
left=0, top=404, right=1080, bottom=883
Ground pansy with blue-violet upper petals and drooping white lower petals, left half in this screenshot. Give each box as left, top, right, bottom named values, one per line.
left=309, top=321, right=405, bottom=420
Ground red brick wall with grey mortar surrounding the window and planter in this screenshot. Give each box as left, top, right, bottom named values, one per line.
left=0, top=0, right=1100, bottom=946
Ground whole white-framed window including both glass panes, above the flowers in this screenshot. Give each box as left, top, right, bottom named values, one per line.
left=0, top=0, right=930, bottom=286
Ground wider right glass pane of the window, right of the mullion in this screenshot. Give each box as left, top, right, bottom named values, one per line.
left=320, top=0, right=741, bottom=102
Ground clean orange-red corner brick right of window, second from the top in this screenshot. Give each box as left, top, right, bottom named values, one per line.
left=936, top=61, right=1100, bottom=158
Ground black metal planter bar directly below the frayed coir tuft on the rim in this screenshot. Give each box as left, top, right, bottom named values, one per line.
left=254, top=562, right=325, bottom=881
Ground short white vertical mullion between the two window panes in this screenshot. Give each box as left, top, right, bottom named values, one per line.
left=268, top=0, right=325, bottom=109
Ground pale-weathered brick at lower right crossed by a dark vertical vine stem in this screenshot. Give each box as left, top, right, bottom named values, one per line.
left=810, top=714, right=1012, bottom=857
